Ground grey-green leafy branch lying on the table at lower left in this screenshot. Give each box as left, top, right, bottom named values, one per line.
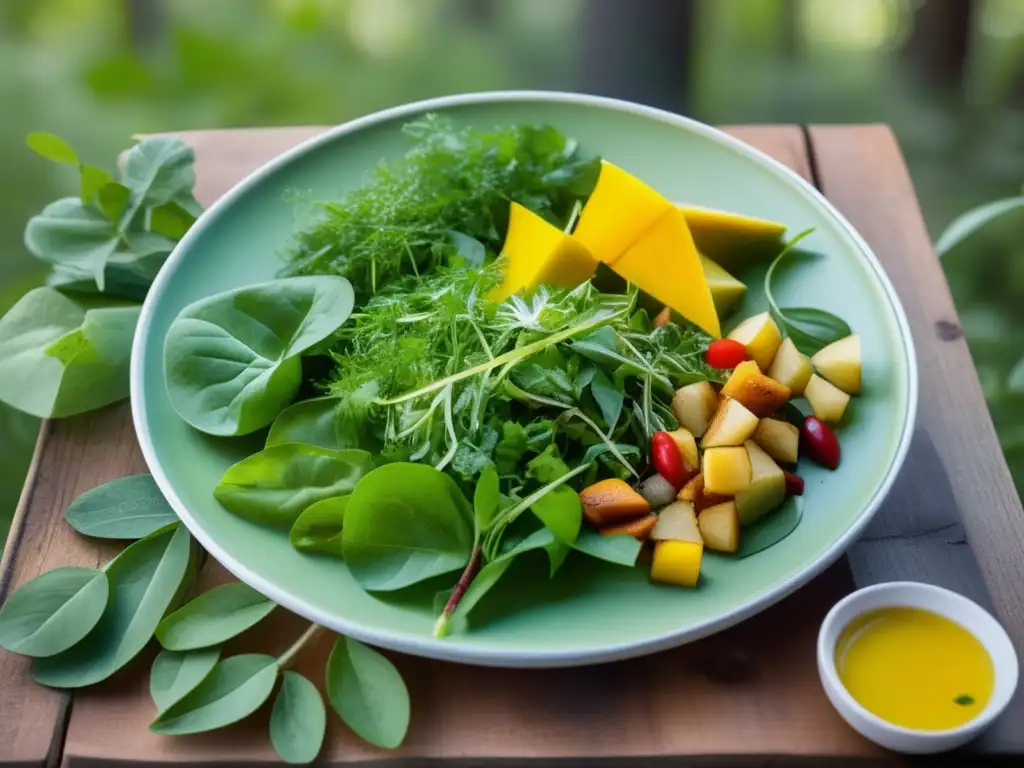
left=0, top=475, right=410, bottom=763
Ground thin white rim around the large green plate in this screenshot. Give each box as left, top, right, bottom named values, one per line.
left=129, top=90, right=919, bottom=668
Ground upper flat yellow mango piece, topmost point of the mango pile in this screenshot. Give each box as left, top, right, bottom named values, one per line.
left=572, top=160, right=672, bottom=264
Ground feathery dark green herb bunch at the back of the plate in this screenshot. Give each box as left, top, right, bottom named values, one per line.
left=288, top=115, right=600, bottom=302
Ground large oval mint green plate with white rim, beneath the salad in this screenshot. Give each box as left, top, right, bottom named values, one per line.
left=131, top=92, right=918, bottom=667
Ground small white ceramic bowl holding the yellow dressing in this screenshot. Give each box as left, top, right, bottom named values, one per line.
left=818, top=582, right=1018, bottom=755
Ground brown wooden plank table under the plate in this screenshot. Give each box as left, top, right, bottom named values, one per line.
left=0, top=125, right=1024, bottom=768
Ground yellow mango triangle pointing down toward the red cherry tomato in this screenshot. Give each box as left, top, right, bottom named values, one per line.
left=610, top=208, right=722, bottom=339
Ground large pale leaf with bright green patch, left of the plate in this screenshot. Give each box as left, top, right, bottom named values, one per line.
left=0, top=288, right=139, bottom=419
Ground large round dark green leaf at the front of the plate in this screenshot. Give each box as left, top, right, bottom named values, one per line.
left=342, top=463, right=473, bottom=591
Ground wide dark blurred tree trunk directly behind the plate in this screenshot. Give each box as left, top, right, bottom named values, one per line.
left=585, top=0, right=695, bottom=114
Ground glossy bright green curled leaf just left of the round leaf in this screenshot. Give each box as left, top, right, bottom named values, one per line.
left=213, top=442, right=373, bottom=528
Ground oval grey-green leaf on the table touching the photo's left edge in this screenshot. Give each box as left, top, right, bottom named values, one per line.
left=0, top=567, right=108, bottom=656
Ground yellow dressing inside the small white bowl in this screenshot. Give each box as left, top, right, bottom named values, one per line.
left=836, top=607, right=995, bottom=730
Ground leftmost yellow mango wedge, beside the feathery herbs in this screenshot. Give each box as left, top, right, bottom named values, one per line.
left=488, top=203, right=598, bottom=301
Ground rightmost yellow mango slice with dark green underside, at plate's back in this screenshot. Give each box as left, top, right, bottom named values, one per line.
left=678, top=204, right=785, bottom=269
